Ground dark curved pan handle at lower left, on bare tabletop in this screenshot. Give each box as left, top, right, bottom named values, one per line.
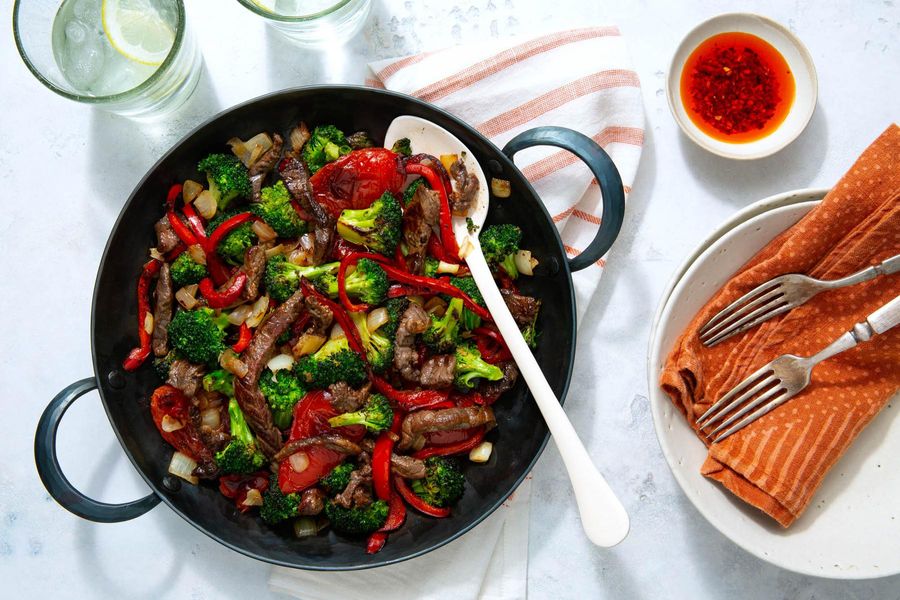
left=34, top=377, right=159, bottom=523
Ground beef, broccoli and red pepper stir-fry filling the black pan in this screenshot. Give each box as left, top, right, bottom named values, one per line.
left=124, top=123, right=540, bottom=553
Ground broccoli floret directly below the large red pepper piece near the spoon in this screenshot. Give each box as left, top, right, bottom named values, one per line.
left=337, top=192, right=403, bottom=256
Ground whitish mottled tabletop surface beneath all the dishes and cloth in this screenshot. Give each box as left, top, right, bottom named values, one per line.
left=0, top=0, right=900, bottom=600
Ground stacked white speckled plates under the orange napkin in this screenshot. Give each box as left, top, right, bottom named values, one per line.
left=648, top=190, right=900, bottom=579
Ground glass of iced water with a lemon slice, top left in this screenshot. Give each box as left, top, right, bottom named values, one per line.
left=13, top=0, right=202, bottom=117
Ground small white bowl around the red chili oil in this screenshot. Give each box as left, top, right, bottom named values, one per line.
left=666, top=13, right=819, bottom=160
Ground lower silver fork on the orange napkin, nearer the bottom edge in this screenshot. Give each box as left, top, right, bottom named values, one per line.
left=697, top=295, right=900, bottom=442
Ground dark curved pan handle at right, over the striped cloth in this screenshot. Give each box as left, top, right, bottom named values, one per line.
left=503, top=127, right=625, bottom=272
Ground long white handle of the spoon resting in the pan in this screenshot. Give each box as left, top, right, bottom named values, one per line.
left=466, top=246, right=629, bottom=547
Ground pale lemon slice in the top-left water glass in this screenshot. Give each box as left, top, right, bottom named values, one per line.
left=101, top=0, right=175, bottom=66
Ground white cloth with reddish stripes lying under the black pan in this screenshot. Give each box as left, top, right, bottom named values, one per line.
left=269, top=26, right=644, bottom=600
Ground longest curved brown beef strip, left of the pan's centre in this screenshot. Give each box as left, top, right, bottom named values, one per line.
left=234, top=290, right=303, bottom=457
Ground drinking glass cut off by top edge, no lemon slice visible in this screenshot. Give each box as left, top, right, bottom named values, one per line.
left=238, top=0, right=371, bottom=46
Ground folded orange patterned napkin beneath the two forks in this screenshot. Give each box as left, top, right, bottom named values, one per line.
left=660, top=125, right=900, bottom=527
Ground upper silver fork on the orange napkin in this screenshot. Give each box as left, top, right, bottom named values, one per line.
left=698, top=254, right=900, bottom=347
